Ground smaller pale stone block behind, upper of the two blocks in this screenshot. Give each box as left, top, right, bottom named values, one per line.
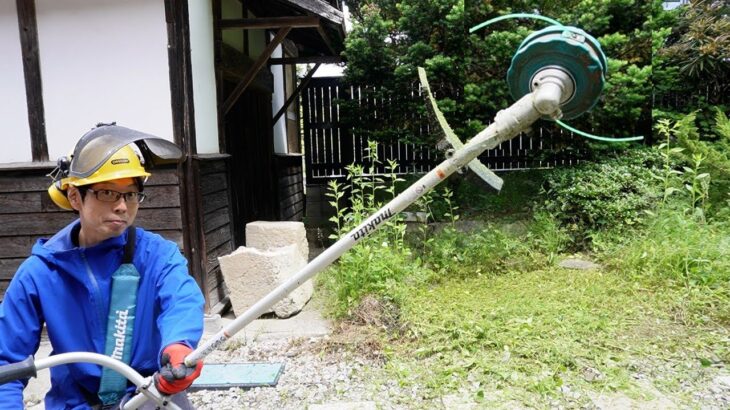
left=246, top=221, right=309, bottom=261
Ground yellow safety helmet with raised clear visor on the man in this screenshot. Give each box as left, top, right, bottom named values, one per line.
left=48, top=123, right=182, bottom=210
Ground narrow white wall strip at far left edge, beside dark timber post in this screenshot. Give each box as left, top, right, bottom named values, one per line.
left=0, top=1, right=32, bottom=163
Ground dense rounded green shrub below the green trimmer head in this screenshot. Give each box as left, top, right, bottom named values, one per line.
left=537, top=148, right=661, bottom=248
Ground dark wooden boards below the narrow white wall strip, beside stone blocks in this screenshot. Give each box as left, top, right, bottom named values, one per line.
left=199, top=155, right=235, bottom=310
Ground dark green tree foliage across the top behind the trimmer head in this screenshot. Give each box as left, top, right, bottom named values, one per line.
left=344, top=0, right=730, bottom=146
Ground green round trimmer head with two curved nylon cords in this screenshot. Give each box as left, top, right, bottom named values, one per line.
left=469, top=13, right=644, bottom=142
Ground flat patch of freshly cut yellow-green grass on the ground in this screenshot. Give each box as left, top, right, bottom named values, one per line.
left=394, top=268, right=642, bottom=406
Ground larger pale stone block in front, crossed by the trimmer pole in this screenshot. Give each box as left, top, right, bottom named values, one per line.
left=218, top=245, right=314, bottom=318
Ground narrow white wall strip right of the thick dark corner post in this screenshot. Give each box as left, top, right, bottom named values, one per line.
left=188, top=0, right=220, bottom=154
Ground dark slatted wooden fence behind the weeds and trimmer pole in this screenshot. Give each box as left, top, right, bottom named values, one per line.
left=301, top=77, right=580, bottom=185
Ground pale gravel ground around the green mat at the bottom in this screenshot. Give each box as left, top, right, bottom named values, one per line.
left=190, top=337, right=443, bottom=410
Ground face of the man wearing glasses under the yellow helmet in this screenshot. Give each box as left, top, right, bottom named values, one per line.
left=68, top=178, right=139, bottom=247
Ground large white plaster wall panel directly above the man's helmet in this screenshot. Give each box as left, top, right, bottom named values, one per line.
left=36, top=0, right=173, bottom=160
